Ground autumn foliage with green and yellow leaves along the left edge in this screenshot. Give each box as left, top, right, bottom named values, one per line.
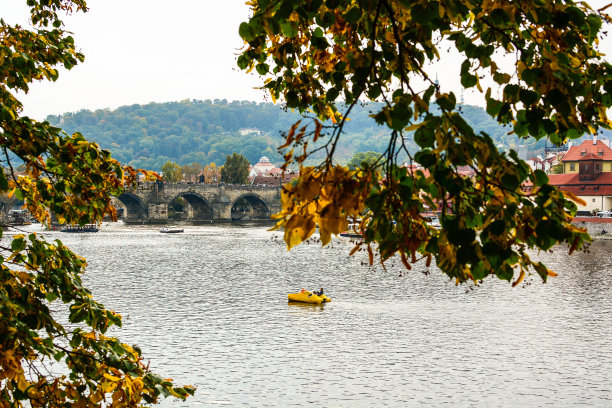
left=0, top=0, right=193, bottom=407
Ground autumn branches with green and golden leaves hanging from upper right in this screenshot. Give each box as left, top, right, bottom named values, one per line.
left=237, top=0, right=612, bottom=284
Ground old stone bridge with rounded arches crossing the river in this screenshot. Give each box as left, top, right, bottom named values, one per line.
left=117, top=182, right=281, bottom=224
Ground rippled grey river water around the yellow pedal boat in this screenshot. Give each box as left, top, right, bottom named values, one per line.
left=11, top=224, right=612, bottom=407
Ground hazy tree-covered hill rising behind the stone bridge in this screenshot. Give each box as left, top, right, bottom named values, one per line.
left=47, top=100, right=568, bottom=171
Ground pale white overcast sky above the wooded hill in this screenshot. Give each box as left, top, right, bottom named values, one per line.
left=0, top=0, right=612, bottom=119
